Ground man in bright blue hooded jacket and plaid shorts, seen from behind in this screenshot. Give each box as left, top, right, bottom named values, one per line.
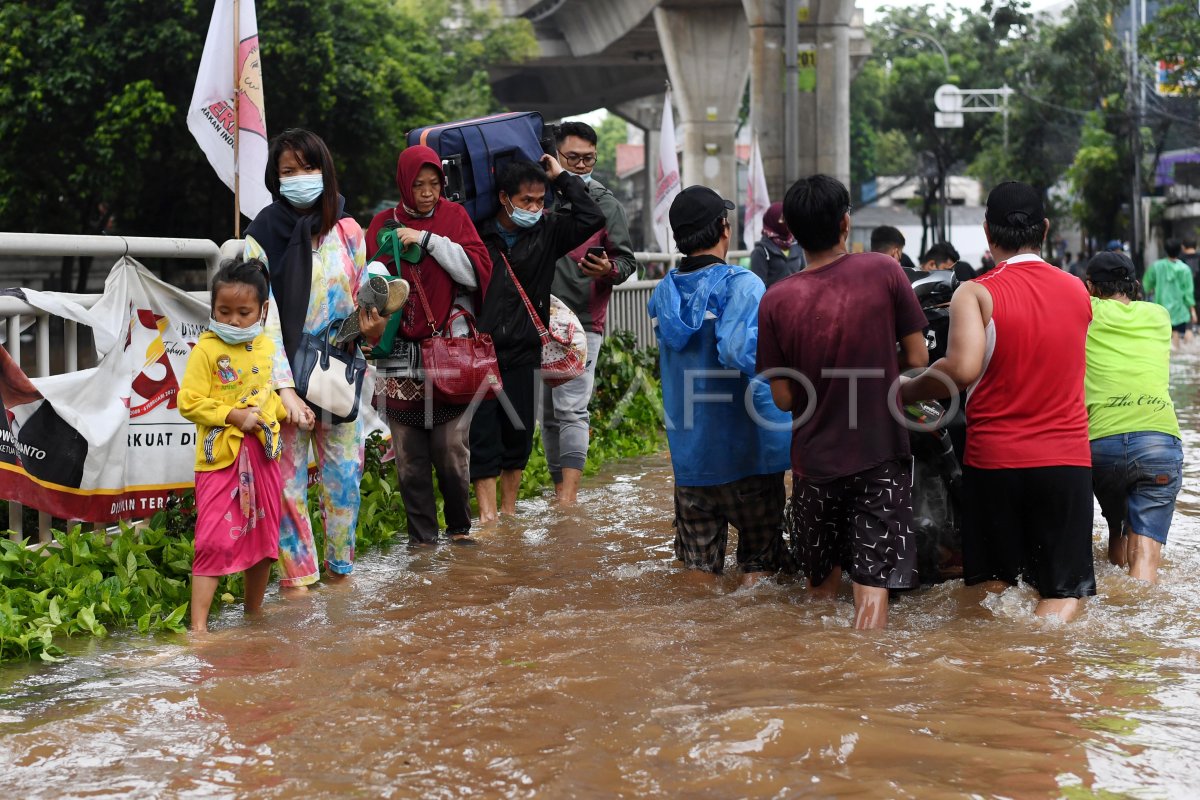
left=648, top=186, right=791, bottom=583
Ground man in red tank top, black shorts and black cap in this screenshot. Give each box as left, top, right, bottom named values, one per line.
left=901, top=181, right=1096, bottom=620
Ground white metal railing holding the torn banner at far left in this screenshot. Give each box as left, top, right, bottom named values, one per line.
left=0, top=233, right=221, bottom=542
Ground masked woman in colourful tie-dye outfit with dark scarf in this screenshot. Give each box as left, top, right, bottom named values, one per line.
left=238, top=128, right=386, bottom=589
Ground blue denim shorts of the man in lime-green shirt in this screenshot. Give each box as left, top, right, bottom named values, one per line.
left=1092, top=431, right=1183, bottom=545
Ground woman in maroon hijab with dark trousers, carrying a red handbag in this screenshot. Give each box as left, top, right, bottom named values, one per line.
left=367, top=145, right=492, bottom=545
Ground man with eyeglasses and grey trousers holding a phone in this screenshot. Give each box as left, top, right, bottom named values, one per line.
left=542, top=122, right=637, bottom=505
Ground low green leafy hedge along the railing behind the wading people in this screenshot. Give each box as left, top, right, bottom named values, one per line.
left=0, top=332, right=662, bottom=662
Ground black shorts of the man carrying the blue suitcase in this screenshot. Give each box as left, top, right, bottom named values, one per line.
left=470, top=365, right=538, bottom=481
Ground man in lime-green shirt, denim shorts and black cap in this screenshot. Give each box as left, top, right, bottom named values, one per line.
left=1084, top=253, right=1190, bottom=583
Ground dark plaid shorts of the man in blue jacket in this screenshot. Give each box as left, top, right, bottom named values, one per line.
left=674, top=473, right=790, bottom=573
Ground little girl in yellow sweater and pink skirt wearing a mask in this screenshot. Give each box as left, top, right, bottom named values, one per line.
left=179, top=259, right=300, bottom=631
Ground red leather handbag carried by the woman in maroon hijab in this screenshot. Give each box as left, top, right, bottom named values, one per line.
left=413, top=270, right=504, bottom=405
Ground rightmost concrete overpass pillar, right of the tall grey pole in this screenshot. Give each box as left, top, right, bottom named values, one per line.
left=799, top=0, right=854, bottom=189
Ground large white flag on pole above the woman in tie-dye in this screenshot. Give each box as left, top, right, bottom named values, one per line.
left=187, top=0, right=271, bottom=219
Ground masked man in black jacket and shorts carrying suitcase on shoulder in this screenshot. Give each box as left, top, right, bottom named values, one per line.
left=470, top=156, right=605, bottom=524
